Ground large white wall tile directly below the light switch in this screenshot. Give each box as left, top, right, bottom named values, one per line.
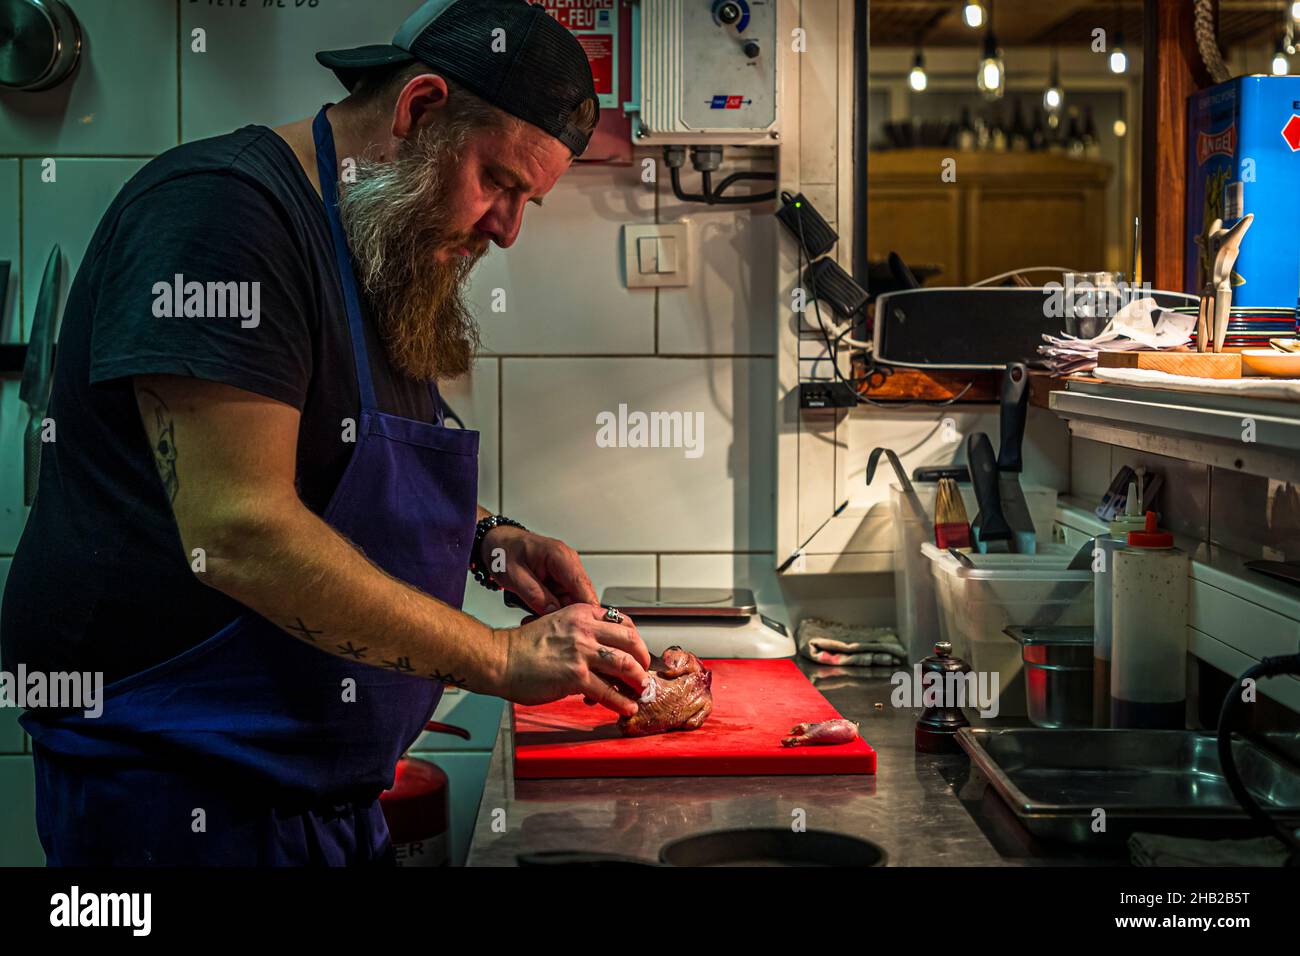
left=502, top=356, right=775, bottom=551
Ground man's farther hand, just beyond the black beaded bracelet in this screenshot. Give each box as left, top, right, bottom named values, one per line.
left=478, top=524, right=599, bottom=614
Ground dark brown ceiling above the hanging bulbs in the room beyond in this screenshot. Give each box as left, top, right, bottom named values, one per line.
left=868, top=0, right=1290, bottom=48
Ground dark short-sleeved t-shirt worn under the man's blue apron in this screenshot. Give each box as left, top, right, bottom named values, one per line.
left=0, top=126, right=436, bottom=682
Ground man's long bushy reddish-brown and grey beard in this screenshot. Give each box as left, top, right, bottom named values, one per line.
left=339, top=122, right=488, bottom=381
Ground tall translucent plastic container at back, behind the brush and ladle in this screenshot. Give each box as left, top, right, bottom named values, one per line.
left=889, top=483, right=1069, bottom=663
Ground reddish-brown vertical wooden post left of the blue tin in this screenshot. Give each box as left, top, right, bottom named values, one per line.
left=1141, top=0, right=1210, bottom=291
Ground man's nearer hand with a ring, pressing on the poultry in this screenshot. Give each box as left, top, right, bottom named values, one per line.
left=498, top=606, right=650, bottom=715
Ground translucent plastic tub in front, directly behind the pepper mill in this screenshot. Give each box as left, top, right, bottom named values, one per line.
left=922, top=546, right=1092, bottom=717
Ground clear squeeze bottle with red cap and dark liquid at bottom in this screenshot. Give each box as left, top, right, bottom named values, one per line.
left=1110, top=511, right=1191, bottom=730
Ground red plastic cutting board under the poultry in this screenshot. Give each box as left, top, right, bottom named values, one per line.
left=514, top=659, right=876, bottom=779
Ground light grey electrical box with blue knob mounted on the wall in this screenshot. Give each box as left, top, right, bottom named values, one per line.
left=632, top=0, right=780, bottom=146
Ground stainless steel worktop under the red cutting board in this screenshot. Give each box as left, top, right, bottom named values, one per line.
left=468, top=661, right=1117, bottom=866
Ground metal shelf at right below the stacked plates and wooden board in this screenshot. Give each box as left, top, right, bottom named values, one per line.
left=1048, top=381, right=1300, bottom=481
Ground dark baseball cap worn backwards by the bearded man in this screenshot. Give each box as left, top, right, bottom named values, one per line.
left=316, top=0, right=599, bottom=156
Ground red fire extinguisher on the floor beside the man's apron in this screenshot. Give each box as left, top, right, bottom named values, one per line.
left=380, top=721, right=469, bottom=866
